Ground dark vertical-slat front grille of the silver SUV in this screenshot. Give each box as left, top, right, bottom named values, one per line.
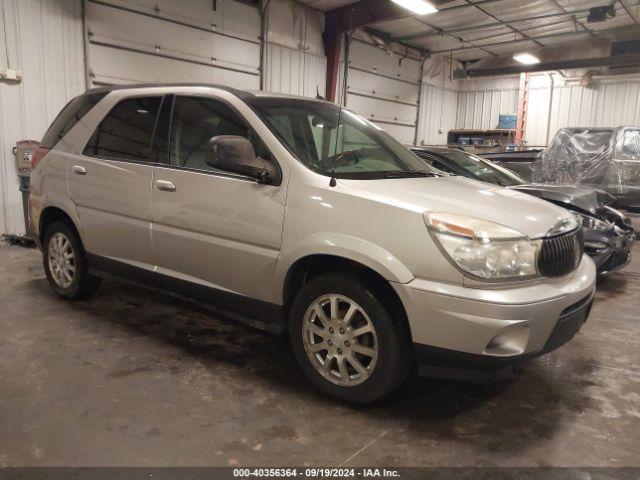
left=538, top=229, right=584, bottom=277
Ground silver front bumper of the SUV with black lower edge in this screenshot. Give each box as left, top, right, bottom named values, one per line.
left=393, top=256, right=596, bottom=378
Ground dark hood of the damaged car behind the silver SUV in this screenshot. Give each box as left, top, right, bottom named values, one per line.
left=509, top=183, right=615, bottom=215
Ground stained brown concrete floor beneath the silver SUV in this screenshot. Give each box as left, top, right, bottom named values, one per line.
left=0, top=242, right=640, bottom=466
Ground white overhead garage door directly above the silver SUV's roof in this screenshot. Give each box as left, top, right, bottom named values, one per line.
left=86, top=0, right=260, bottom=90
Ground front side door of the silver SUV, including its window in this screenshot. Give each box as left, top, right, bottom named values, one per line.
left=151, top=96, right=284, bottom=306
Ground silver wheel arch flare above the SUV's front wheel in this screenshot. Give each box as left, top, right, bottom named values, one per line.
left=274, top=232, right=414, bottom=304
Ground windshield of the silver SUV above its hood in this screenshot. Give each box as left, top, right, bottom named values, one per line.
left=248, top=97, right=439, bottom=179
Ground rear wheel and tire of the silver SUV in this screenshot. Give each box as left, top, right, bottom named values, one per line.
left=42, top=221, right=101, bottom=300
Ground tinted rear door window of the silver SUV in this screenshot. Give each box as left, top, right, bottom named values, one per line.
left=83, top=97, right=162, bottom=162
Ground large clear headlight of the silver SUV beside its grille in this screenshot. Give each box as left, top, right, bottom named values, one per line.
left=425, top=213, right=542, bottom=280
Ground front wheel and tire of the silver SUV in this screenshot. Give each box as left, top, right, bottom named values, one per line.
left=289, top=273, right=411, bottom=403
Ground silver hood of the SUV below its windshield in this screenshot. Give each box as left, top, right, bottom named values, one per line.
left=340, top=176, right=573, bottom=238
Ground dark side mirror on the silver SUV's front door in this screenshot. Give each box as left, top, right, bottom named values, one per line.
left=206, top=135, right=280, bottom=184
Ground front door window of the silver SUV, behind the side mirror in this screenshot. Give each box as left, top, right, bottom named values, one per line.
left=169, top=97, right=265, bottom=172
